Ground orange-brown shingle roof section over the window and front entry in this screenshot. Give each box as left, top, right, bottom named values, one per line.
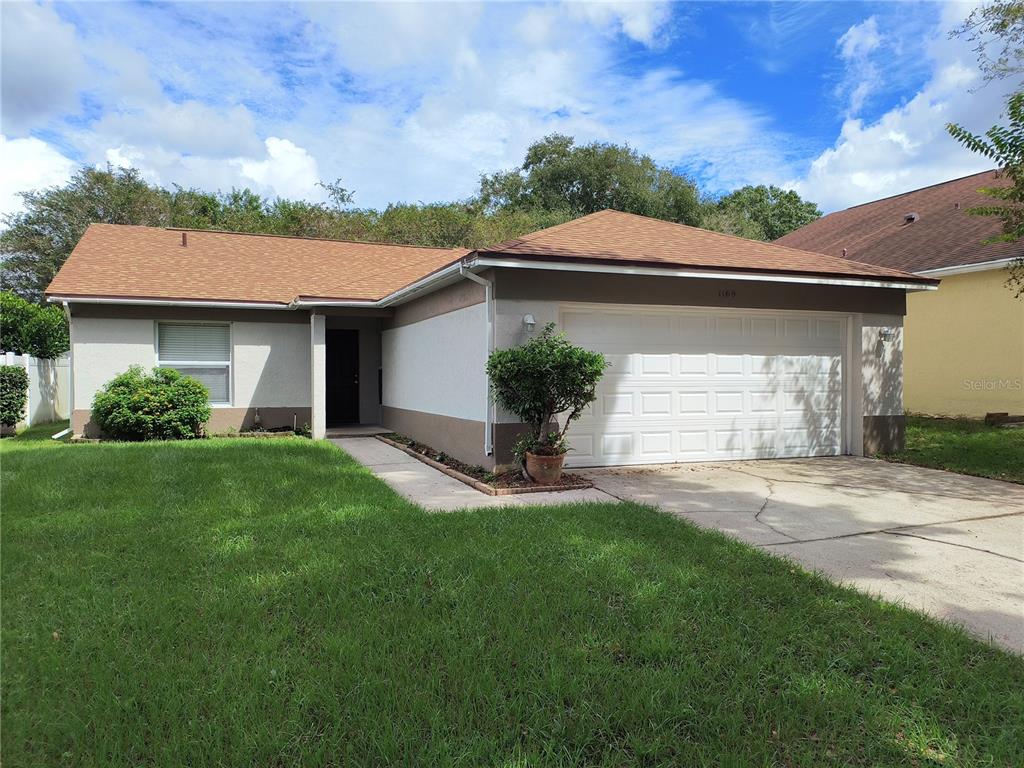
left=46, top=224, right=468, bottom=304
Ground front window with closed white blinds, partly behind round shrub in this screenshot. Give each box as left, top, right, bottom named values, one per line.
left=157, top=323, right=231, bottom=404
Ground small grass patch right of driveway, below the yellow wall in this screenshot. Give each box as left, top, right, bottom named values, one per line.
left=882, top=416, right=1024, bottom=483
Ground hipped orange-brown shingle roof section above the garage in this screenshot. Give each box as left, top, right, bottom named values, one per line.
left=480, top=210, right=933, bottom=282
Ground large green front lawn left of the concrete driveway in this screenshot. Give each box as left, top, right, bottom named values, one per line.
left=6, top=428, right=1024, bottom=767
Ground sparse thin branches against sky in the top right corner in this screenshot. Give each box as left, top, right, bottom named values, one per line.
left=949, top=0, right=1024, bottom=83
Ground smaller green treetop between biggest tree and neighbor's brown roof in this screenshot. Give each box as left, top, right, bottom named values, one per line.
left=705, top=184, right=821, bottom=241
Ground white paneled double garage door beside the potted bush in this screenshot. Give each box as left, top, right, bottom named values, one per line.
left=561, top=306, right=845, bottom=467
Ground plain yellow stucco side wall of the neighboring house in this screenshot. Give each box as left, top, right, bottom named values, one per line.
left=904, top=268, right=1024, bottom=417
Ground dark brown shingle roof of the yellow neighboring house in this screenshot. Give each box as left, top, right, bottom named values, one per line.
left=775, top=171, right=1024, bottom=272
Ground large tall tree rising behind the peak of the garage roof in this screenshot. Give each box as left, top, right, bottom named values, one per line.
left=479, top=133, right=700, bottom=224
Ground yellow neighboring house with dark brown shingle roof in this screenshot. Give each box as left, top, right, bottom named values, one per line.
left=776, top=171, right=1024, bottom=417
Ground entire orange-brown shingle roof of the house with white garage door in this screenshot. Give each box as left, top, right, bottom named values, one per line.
left=46, top=211, right=935, bottom=305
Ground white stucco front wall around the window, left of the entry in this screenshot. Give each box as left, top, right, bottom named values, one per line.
left=71, top=306, right=310, bottom=435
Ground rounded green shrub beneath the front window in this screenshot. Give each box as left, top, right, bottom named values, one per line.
left=92, top=366, right=210, bottom=440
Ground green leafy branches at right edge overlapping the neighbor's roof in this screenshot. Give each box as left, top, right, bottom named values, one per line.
left=946, top=93, right=1024, bottom=298
